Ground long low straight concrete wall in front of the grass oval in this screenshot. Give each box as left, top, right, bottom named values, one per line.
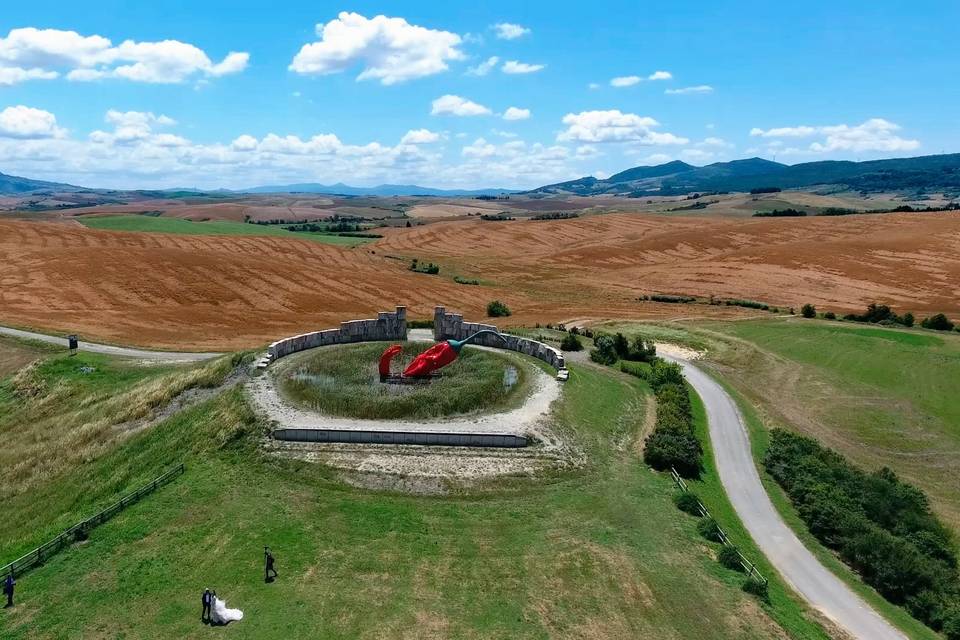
left=273, top=429, right=528, bottom=449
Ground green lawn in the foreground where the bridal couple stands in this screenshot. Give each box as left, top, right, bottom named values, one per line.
left=0, top=360, right=809, bottom=639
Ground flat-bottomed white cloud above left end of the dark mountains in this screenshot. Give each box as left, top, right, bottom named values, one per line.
left=557, top=109, right=690, bottom=145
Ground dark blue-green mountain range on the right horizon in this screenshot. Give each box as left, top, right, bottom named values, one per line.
left=527, top=153, right=960, bottom=197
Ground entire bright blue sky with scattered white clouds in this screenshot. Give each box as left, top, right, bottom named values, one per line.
left=0, top=0, right=960, bottom=188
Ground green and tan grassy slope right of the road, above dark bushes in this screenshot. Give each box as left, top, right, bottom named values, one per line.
left=696, top=320, right=960, bottom=532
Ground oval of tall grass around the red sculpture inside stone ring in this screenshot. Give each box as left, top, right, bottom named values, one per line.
left=275, top=342, right=529, bottom=418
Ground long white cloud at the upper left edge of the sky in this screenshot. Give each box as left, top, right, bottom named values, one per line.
left=0, top=27, right=250, bottom=84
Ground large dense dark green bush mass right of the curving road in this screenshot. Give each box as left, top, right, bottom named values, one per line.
left=763, top=429, right=960, bottom=627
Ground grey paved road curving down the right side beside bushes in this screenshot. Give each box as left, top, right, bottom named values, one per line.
left=670, top=358, right=906, bottom=640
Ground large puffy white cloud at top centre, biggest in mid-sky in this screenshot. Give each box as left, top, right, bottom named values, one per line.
left=290, top=11, right=464, bottom=85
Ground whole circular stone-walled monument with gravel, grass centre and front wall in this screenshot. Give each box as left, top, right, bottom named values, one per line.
left=249, top=307, right=576, bottom=493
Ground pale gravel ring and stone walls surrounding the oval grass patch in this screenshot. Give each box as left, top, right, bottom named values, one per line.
left=249, top=306, right=577, bottom=493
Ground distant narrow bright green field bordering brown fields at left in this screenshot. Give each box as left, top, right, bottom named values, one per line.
left=75, top=215, right=370, bottom=247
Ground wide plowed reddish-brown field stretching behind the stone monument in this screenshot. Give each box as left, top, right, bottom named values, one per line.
left=0, top=214, right=960, bottom=349
